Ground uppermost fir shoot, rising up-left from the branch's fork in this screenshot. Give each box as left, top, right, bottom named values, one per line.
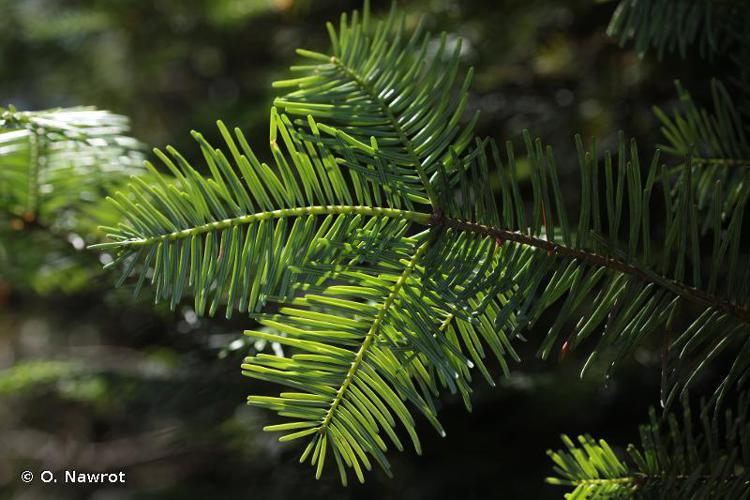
left=274, top=4, right=478, bottom=204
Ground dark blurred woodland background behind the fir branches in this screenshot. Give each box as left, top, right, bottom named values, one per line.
left=0, top=0, right=726, bottom=500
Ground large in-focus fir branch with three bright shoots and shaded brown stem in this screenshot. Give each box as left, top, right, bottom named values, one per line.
left=95, top=0, right=750, bottom=482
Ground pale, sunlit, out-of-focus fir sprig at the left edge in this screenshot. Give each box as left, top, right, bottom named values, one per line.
left=0, top=107, right=142, bottom=223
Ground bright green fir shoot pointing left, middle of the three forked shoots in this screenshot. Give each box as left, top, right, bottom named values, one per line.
left=92, top=111, right=434, bottom=317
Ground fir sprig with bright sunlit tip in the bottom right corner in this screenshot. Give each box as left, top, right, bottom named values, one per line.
left=547, top=395, right=750, bottom=499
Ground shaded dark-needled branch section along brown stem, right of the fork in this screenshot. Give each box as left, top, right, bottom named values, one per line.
left=446, top=131, right=750, bottom=412
